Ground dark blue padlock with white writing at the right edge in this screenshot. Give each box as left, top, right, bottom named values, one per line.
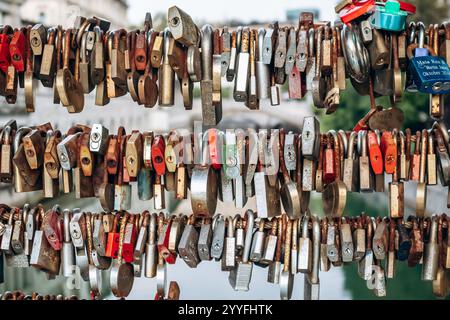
left=409, top=23, right=450, bottom=94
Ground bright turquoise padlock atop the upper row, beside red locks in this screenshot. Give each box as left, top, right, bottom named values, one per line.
left=370, top=0, right=408, bottom=32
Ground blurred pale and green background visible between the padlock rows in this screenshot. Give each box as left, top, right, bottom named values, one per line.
left=0, top=0, right=450, bottom=299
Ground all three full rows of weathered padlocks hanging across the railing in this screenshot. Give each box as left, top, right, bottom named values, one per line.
left=0, top=0, right=450, bottom=300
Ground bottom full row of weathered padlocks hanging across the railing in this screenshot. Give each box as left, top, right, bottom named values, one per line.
left=0, top=205, right=450, bottom=300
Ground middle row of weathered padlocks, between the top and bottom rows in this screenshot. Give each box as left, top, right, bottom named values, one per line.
left=0, top=117, right=450, bottom=218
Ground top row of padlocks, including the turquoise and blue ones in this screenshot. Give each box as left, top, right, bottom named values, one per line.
left=0, top=0, right=450, bottom=129
